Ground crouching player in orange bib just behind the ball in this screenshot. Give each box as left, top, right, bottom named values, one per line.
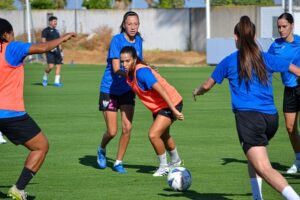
left=121, top=46, right=184, bottom=176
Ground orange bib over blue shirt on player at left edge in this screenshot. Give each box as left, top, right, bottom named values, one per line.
left=0, top=41, right=31, bottom=118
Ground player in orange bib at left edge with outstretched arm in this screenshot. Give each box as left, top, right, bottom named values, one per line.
left=0, top=18, right=75, bottom=200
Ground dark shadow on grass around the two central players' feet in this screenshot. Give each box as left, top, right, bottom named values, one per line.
left=79, top=155, right=156, bottom=174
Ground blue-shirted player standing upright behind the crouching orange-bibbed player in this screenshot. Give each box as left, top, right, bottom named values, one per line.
left=97, top=11, right=143, bottom=173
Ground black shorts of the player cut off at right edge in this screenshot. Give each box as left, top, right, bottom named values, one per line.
left=283, top=86, right=300, bottom=113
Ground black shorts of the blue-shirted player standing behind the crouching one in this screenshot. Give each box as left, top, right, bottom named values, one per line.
left=99, top=90, right=135, bottom=112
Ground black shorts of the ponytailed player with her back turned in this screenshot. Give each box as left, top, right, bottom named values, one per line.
left=235, top=111, right=279, bottom=154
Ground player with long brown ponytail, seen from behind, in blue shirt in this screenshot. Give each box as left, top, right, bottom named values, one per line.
left=193, top=16, right=300, bottom=200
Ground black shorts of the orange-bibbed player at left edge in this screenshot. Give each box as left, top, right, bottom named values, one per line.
left=0, top=114, right=41, bottom=145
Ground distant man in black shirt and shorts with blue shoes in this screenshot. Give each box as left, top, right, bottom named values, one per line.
left=42, top=16, right=63, bottom=87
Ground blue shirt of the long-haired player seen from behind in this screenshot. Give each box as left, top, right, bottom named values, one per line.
left=211, top=51, right=290, bottom=114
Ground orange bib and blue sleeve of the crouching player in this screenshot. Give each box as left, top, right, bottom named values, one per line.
left=126, top=64, right=182, bottom=113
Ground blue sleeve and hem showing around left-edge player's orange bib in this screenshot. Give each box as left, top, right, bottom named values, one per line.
left=0, top=41, right=32, bottom=118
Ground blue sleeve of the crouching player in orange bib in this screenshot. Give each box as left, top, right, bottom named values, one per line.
left=136, top=68, right=157, bottom=91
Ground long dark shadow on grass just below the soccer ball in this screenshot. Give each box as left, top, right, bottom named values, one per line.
left=158, top=188, right=252, bottom=200
